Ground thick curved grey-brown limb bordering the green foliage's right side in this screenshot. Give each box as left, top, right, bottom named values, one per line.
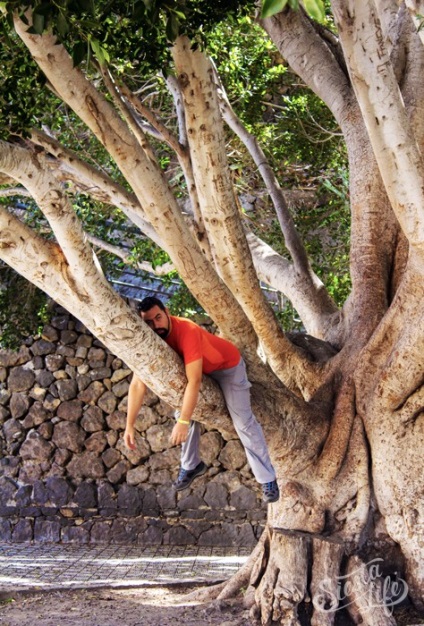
left=261, top=11, right=399, bottom=352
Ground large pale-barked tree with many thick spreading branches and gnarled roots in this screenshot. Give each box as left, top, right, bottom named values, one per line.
left=0, top=0, right=424, bottom=624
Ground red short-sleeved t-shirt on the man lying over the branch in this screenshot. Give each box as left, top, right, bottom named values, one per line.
left=165, top=315, right=240, bottom=374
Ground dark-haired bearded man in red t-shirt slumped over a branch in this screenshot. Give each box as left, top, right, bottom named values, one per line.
left=124, top=297, right=280, bottom=502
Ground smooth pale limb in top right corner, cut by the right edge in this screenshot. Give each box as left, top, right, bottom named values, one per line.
left=333, top=0, right=424, bottom=255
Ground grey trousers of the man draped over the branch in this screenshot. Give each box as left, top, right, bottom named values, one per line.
left=177, top=359, right=275, bottom=483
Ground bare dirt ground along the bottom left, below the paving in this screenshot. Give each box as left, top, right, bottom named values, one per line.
left=0, top=586, right=250, bottom=626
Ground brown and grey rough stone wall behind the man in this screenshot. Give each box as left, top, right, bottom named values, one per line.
left=0, top=309, right=266, bottom=545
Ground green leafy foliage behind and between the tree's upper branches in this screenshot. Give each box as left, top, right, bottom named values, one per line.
left=0, top=0, right=349, bottom=336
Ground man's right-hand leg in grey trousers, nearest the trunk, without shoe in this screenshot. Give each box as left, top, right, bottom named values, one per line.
left=210, top=360, right=276, bottom=485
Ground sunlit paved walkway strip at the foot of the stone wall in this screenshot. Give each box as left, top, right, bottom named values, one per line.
left=0, top=543, right=251, bottom=594
